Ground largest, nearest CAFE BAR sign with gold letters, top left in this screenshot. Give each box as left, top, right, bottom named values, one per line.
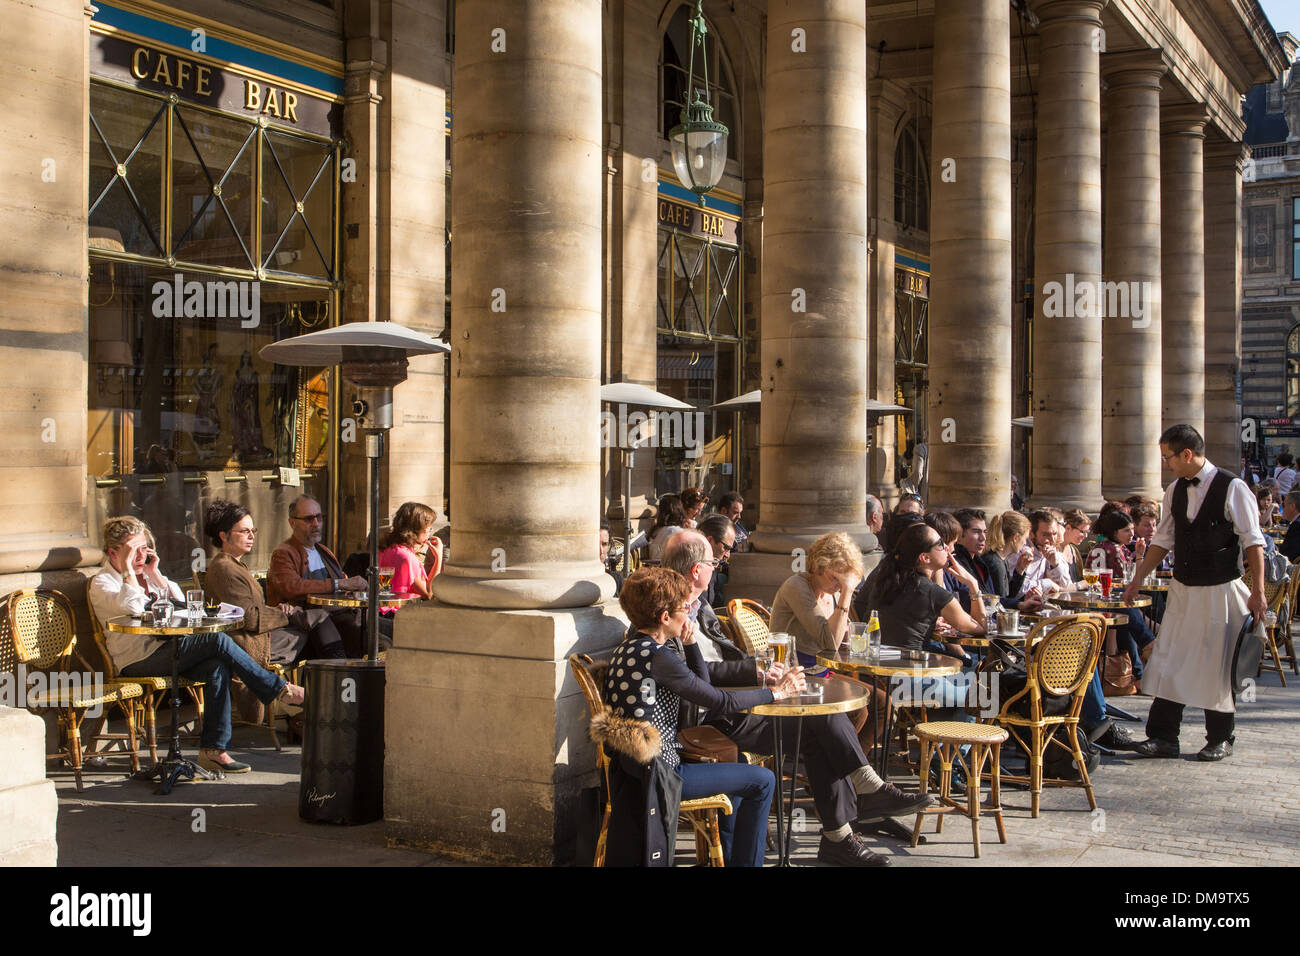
left=90, top=34, right=341, bottom=137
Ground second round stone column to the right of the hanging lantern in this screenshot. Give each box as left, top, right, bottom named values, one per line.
left=930, top=0, right=1011, bottom=514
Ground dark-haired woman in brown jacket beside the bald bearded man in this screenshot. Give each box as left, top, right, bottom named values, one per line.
left=203, top=499, right=346, bottom=667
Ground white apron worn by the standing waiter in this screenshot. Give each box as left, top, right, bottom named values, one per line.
left=1141, top=579, right=1251, bottom=714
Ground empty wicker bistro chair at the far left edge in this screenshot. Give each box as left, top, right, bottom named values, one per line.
left=5, top=588, right=144, bottom=792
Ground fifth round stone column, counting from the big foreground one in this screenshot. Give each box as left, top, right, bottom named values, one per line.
left=1101, top=51, right=1166, bottom=501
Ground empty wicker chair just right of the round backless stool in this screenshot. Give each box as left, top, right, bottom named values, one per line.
left=969, top=614, right=1106, bottom=817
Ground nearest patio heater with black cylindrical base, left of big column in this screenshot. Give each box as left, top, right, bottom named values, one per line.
left=260, top=323, right=451, bottom=823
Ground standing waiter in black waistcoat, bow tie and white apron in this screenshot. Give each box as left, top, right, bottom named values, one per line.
left=1123, top=425, right=1268, bottom=761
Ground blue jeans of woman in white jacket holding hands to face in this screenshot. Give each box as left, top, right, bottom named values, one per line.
left=118, top=633, right=285, bottom=750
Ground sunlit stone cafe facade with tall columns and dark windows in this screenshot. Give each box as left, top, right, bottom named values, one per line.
left=0, top=0, right=1283, bottom=861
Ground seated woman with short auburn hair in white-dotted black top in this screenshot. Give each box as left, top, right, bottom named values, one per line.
left=592, top=567, right=803, bottom=866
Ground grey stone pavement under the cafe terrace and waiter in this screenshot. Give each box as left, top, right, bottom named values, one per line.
left=51, top=674, right=1300, bottom=866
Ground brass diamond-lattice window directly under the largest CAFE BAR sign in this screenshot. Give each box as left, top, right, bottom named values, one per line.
left=90, top=79, right=339, bottom=282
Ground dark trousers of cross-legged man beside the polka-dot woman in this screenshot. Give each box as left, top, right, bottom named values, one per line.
left=711, top=714, right=867, bottom=830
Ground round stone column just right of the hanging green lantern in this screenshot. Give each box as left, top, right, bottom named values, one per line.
left=751, top=0, right=870, bottom=554
